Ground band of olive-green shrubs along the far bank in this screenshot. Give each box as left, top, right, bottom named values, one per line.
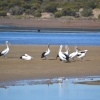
left=0, top=0, right=100, bottom=17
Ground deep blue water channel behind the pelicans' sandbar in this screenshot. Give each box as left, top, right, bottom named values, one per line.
left=0, top=31, right=100, bottom=46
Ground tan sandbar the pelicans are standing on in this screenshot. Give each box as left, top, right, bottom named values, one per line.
left=0, top=45, right=100, bottom=82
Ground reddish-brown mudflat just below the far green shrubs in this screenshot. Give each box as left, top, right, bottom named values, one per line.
left=0, top=18, right=100, bottom=31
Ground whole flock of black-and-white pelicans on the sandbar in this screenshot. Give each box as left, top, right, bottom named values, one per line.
left=0, top=41, right=88, bottom=62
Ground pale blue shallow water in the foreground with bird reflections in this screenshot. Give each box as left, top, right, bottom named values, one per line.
left=0, top=77, right=100, bottom=100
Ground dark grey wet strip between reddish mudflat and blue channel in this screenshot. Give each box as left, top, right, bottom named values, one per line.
left=0, top=25, right=100, bottom=31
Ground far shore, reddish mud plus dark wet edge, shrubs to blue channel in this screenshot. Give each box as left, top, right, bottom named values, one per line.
left=0, top=18, right=100, bottom=31
